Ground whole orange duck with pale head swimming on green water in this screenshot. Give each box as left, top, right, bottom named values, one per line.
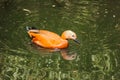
left=26, top=27, right=79, bottom=49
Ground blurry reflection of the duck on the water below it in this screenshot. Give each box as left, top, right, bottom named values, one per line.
left=31, top=44, right=77, bottom=60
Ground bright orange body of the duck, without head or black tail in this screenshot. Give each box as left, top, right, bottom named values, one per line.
left=29, top=30, right=68, bottom=48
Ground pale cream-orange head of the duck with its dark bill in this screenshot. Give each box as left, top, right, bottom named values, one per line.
left=61, top=30, right=80, bottom=43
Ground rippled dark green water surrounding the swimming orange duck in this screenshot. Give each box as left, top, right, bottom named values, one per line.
left=0, top=0, right=120, bottom=80
